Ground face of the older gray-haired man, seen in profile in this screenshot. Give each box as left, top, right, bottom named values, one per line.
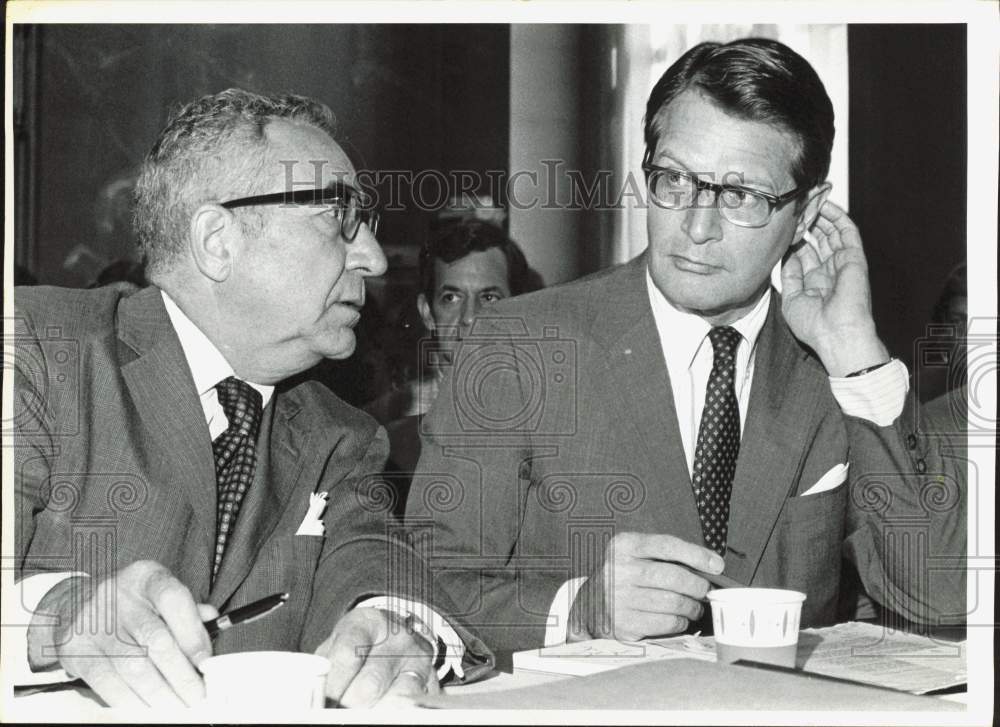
left=220, top=119, right=386, bottom=380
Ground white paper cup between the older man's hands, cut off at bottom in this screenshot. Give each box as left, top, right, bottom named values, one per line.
left=199, top=651, right=330, bottom=711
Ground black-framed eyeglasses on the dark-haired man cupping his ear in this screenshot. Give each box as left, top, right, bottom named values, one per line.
left=642, top=163, right=804, bottom=227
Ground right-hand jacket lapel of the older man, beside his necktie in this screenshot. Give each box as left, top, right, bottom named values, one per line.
left=211, top=387, right=319, bottom=607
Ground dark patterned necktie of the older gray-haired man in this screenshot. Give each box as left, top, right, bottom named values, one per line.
left=212, top=376, right=263, bottom=580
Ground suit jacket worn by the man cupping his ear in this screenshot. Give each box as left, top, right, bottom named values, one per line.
left=407, top=255, right=964, bottom=649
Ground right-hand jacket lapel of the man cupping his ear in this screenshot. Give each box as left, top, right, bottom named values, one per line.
left=726, top=295, right=822, bottom=583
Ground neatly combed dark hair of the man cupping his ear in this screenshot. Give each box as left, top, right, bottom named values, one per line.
left=643, top=38, right=834, bottom=189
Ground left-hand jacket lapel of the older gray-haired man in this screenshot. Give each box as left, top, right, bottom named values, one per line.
left=118, top=287, right=216, bottom=596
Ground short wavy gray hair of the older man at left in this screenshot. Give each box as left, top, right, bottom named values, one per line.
left=132, top=88, right=336, bottom=278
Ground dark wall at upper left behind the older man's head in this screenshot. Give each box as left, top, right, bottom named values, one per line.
left=14, top=25, right=509, bottom=285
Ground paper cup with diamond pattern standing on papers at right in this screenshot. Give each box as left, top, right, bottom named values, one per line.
left=708, top=588, right=806, bottom=667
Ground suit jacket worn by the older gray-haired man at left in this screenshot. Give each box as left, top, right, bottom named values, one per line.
left=14, top=287, right=485, bottom=672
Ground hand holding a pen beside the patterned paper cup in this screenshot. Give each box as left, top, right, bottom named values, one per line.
left=567, top=533, right=725, bottom=641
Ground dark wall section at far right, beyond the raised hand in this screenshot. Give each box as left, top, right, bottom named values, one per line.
left=838, top=25, right=964, bottom=370
